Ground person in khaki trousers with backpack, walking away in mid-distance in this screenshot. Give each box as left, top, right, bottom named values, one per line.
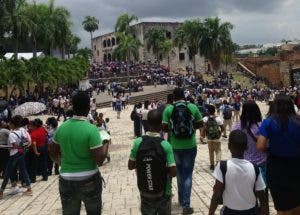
left=201, top=105, right=223, bottom=170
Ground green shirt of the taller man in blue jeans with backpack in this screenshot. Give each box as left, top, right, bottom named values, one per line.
left=163, top=101, right=202, bottom=149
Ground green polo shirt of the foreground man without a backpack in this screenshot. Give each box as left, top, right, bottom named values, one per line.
left=53, top=117, right=102, bottom=177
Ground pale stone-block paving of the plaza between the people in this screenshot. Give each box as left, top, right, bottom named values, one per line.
left=0, top=104, right=275, bottom=215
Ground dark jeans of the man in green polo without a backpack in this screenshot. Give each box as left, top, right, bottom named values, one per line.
left=59, top=172, right=102, bottom=215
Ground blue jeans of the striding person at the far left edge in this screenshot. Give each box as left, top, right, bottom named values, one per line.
left=1, top=153, right=30, bottom=190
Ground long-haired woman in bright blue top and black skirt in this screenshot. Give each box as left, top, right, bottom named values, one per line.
left=257, top=95, right=300, bottom=215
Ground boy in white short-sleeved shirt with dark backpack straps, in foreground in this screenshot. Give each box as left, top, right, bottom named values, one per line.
left=209, top=130, right=268, bottom=215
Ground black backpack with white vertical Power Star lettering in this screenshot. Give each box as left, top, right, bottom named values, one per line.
left=136, top=136, right=168, bottom=194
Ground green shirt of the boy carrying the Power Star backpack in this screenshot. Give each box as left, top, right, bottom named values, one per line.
left=129, top=132, right=175, bottom=196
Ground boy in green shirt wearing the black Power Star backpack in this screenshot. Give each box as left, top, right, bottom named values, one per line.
left=128, top=110, right=176, bottom=215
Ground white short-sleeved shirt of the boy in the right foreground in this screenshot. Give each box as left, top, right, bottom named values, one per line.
left=213, top=158, right=266, bottom=210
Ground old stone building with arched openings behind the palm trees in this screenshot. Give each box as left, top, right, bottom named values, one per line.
left=92, top=22, right=207, bottom=72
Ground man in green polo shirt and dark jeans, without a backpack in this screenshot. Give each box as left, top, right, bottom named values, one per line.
left=49, top=92, right=107, bottom=215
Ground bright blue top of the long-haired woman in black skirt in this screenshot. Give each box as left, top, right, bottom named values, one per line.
left=259, top=117, right=300, bottom=157
